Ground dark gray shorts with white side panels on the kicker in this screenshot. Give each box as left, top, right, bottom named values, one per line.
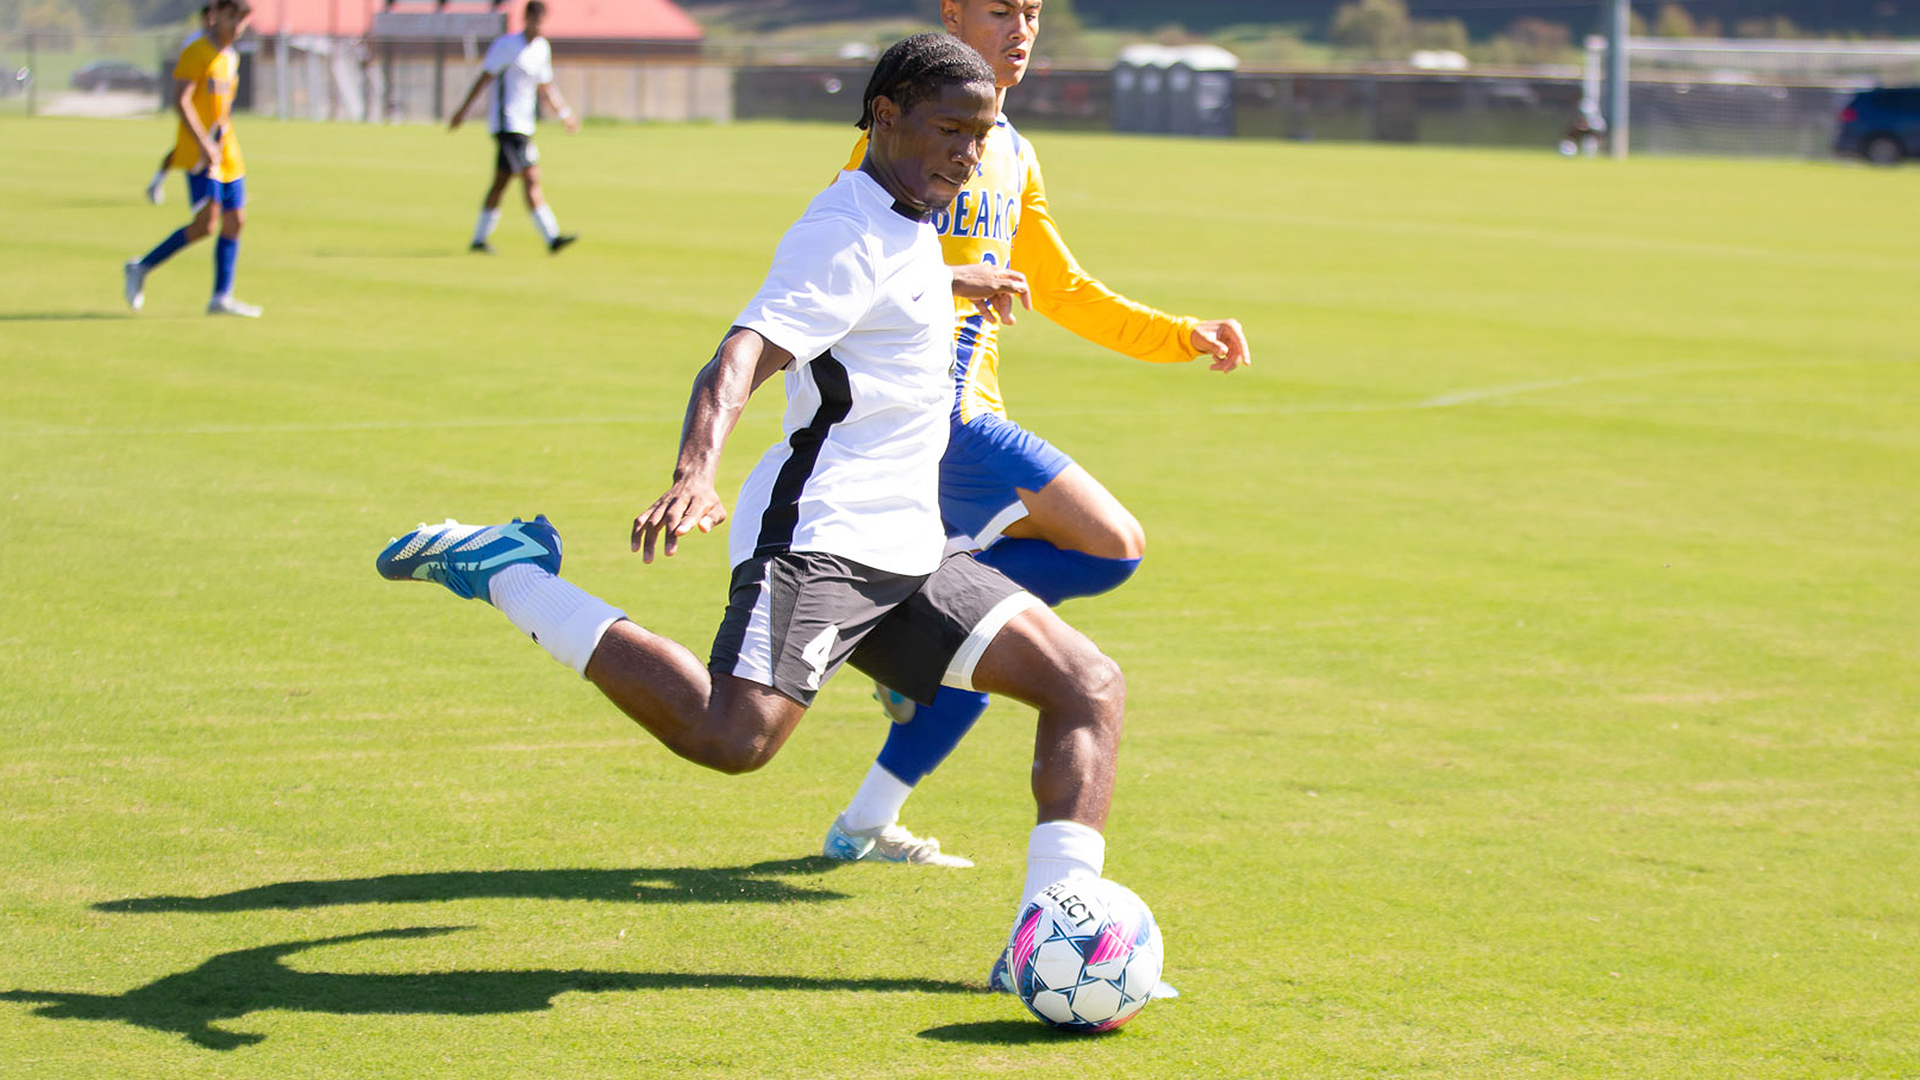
left=707, top=552, right=1041, bottom=705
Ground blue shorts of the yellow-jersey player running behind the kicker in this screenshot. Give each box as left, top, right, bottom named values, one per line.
left=941, top=413, right=1073, bottom=548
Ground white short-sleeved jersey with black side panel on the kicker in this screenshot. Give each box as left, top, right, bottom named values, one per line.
left=728, top=169, right=954, bottom=575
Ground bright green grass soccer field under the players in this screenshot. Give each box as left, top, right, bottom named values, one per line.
left=0, top=121, right=1920, bottom=1080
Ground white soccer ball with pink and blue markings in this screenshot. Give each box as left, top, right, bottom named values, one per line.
left=1008, top=876, right=1162, bottom=1032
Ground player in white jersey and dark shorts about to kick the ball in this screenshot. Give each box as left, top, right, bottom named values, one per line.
left=376, top=35, right=1125, bottom=991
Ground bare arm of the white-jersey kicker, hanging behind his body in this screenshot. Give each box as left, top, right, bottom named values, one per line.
left=634, top=327, right=793, bottom=563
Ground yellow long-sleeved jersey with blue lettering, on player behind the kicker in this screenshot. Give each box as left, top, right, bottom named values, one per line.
left=847, top=115, right=1200, bottom=423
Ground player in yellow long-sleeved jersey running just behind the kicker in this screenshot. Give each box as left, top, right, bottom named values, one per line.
left=822, top=0, right=1252, bottom=880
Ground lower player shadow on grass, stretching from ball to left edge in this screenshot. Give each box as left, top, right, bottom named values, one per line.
left=0, top=926, right=979, bottom=1049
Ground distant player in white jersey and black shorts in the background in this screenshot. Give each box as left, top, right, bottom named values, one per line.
left=447, top=0, right=580, bottom=254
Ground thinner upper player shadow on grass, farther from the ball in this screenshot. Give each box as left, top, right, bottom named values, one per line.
left=94, top=855, right=847, bottom=913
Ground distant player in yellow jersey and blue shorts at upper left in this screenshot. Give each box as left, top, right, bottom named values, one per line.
left=125, top=0, right=259, bottom=319
